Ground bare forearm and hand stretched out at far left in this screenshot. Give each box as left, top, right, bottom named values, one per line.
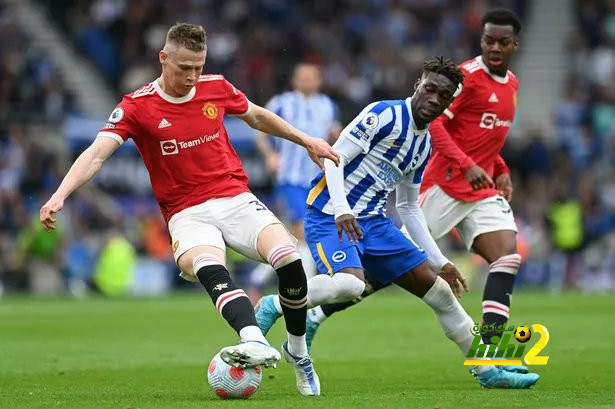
left=40, top=137, right=120, bottom=231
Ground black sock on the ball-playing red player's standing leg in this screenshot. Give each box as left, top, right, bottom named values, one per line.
left=276, top=260, right=307, bottom=336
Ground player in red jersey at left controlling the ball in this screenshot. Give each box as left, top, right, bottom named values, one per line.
left=40, top=23, right=338, bottom=395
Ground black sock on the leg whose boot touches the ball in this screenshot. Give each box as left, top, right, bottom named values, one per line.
left=196, top=264, right=258, bottom=334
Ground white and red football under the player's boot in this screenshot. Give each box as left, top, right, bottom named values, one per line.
left=207, top=354, right=263, bottom=399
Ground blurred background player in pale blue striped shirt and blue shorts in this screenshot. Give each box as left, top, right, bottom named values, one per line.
left=250, top=63, right=341, bottom=291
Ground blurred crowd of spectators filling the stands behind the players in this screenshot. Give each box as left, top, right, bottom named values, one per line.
left=0, top=0, right=615, bottom=295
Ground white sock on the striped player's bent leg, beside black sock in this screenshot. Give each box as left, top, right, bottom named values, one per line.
left=308, top=273, right=365, bottom=307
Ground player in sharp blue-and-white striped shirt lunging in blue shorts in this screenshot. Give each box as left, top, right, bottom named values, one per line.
left=256, top=57, right=538, bottom=388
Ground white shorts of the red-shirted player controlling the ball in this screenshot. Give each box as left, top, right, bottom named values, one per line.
left=169, top=192, right=280, bottom=263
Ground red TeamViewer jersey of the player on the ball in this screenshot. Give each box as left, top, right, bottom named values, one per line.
left=98, top=75, right=249, bottom=222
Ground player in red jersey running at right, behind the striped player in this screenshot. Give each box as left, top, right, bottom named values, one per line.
left=307, top=9, right=540, bottom=387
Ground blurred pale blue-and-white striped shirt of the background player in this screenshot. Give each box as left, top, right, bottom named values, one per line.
left=265, top=91, right=338, bottom=188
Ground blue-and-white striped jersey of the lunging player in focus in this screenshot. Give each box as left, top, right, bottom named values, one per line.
left=307, top=98, right=431, bottom=218
